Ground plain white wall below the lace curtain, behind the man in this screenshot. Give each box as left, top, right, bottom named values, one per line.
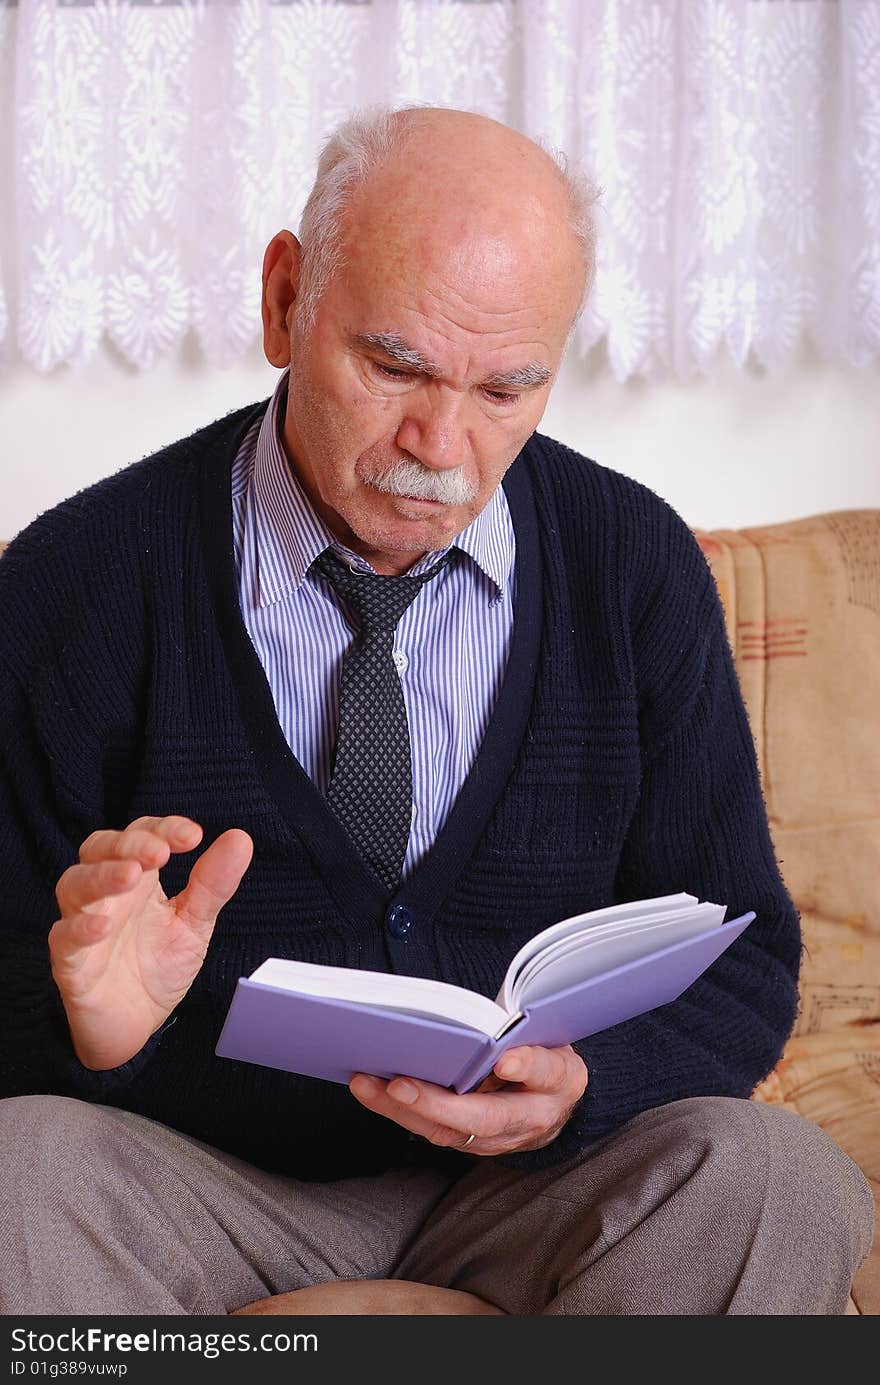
left=0, top=338, right=880, bottom=537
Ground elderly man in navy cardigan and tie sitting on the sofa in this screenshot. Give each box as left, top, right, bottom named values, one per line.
left=0, top=109, right=873, bottom=1314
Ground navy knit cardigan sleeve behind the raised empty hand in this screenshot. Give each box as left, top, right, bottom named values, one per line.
left=0, top=543, right=170, bottom=1101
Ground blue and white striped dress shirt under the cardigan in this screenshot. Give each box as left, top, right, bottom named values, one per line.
left=231, top=371, right=516, bottom=878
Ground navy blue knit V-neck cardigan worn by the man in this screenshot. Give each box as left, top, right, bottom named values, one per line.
left=0, top=400, right=801, bottom=1180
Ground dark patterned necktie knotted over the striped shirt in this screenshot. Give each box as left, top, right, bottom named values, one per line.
left=312, top=548, right=449, bottom=891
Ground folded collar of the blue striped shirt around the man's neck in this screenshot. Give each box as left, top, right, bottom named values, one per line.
left=251, top=370, right=514, bottom=607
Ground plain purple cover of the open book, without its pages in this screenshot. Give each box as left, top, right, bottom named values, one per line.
left=215, top=913, right=755, bottom=1093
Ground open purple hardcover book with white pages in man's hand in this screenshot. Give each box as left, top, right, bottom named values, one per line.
left=215, top=895, right=755, bottom=1093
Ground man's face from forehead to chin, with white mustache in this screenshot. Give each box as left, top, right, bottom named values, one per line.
left=275, top=189, right=579, bottom=572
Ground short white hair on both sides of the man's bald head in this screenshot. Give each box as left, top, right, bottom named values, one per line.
left=297, top=105, right=601, bottom=331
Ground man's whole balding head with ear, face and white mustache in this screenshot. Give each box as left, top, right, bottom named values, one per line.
left=262, top=108, right=593, bottom=575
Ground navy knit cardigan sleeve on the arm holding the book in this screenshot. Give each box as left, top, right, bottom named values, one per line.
left=502, top=520, right=801, bottom=1169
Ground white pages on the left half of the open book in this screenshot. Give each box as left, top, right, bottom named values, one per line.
left=249, top=957, right=509, bottom=1035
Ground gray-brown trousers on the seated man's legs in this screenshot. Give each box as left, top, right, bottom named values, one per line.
left=0, top=1096, right=874, bottom=1316
